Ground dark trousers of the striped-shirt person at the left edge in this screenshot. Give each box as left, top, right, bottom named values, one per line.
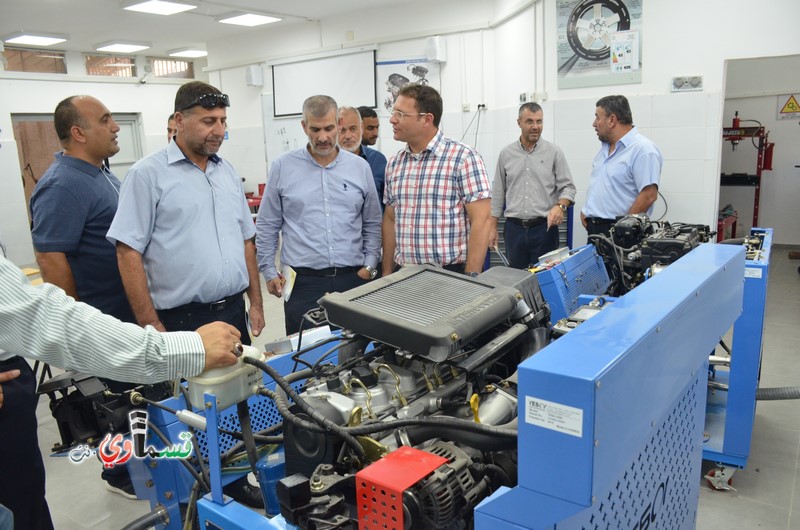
left=0, top=357, right=53, bottom=530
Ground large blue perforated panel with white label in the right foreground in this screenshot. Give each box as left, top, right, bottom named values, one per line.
left=475, top=245, right=745, bottom=530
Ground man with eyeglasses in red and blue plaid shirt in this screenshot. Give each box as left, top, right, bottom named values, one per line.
left=383, top=84, right=492, bottom=276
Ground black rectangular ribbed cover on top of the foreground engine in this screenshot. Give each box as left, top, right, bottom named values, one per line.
left=319, top=265, right=518, bottom=362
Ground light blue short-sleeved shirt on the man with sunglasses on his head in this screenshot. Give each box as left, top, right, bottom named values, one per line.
left=107, top=142, right=255, bottom=310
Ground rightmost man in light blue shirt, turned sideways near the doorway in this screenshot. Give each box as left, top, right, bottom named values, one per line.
left=581, top=96, right=664, bottom=235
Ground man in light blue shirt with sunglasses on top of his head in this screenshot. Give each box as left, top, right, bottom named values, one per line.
left=107, top=81, right=264, bottom=506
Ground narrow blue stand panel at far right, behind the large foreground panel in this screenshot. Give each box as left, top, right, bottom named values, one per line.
left=703, top=228, right=772, bottom=468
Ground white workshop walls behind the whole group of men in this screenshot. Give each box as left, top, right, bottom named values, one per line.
left=0, top=0, right=800, bottom=262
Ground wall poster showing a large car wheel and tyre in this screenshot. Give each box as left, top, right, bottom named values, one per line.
left=556, top=0, right=644, bottom=88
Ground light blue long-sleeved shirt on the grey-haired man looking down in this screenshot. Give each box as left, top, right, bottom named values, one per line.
left=256, top=147, right=381, bottom=280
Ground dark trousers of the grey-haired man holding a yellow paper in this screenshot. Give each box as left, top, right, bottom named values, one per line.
left=283, top=271, right=366, bottom=335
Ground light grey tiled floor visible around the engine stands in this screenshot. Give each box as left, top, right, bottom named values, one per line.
left=34, top=246, right=800, bottom=530
